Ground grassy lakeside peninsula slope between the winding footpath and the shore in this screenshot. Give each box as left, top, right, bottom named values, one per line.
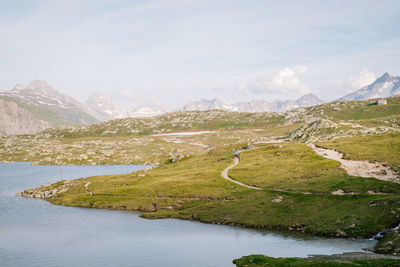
left=21, top=138, right=400, bottom=237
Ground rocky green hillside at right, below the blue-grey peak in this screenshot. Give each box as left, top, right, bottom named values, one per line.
left=286, top=96, right=400, bottom=143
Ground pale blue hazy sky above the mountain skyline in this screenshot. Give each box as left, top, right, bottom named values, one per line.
left=0, top=0, right=400, bottom=110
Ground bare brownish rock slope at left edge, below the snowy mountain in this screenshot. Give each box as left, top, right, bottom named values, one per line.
left=0, top=98, right=52, bottom=135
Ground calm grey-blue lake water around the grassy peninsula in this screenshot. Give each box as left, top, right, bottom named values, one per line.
left=0, top=163, right=375, bottom=266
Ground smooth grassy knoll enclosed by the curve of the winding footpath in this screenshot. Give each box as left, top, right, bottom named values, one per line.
left=229, top=144, right=400, bottom=194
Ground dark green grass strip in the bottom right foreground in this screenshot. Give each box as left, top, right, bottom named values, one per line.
left=233, top=255, right=400, bottom=267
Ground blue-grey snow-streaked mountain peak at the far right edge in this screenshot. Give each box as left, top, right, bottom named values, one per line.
left=339, top=72, right=400, bottom=101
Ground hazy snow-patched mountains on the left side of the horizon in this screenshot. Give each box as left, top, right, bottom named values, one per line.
left=0, top=80, right=162, bottom=135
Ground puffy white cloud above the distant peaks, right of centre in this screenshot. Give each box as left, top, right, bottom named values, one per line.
left=238, top=65, right=310, bottom=98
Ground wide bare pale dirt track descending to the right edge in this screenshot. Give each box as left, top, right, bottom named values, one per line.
left=309, top=144, right=400, bottom=183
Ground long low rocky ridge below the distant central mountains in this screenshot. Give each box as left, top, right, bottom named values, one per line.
left=38, top=110, right=284, bottom=138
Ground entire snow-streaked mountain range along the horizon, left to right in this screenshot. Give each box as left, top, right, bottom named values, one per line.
left=0, top=73, right=400, bottom=135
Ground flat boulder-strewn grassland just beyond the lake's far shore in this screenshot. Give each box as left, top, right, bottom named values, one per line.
left=0, top=125, right=298, bottom=165
